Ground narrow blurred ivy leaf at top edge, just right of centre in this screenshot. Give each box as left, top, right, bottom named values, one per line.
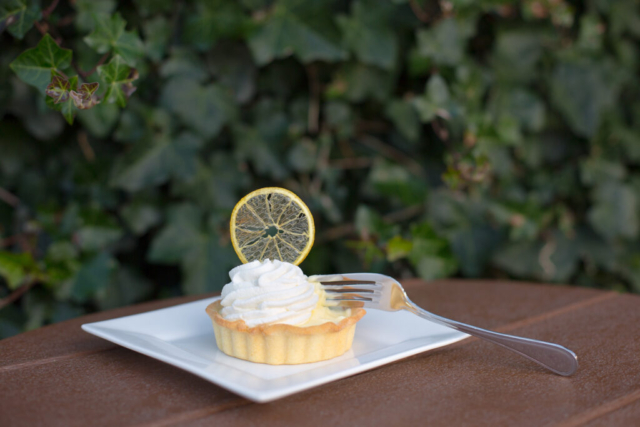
left=338, top=0, right=398, bottom=70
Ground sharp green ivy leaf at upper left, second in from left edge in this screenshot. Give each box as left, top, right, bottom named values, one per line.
left=84, top=13, right=144, bottom=65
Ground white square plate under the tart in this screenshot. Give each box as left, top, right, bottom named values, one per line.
left=82, top=297, right=468, bottom=402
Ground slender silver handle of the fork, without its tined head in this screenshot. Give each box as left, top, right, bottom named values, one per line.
left=407, top=304, right=578, bottom=376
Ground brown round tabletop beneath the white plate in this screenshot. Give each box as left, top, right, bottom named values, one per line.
left=0, top=280, right=640, bottom=427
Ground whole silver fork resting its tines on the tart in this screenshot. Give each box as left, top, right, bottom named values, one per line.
left=316, top=273, right=578, bottom=376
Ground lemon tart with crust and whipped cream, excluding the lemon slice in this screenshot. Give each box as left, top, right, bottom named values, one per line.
left=206, top=259, right=366, bottom=365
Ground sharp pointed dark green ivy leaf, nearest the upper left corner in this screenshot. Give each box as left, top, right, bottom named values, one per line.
left=9, top=34, right=72, bottom=93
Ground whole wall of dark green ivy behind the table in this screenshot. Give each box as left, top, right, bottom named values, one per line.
left=0, top=0, right=640, bottom=337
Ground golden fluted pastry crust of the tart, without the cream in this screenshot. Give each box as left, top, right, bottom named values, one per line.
left=206, top=300, right=366, bottom=365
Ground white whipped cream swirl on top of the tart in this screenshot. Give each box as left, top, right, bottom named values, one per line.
left=220, top=259, right=319, bottom=327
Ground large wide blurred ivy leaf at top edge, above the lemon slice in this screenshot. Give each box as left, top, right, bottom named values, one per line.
left=248, top=0, right=346, bottom=65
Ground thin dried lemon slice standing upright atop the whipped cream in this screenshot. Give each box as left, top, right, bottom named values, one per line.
left=230, top=187, right=316, bottom=265
